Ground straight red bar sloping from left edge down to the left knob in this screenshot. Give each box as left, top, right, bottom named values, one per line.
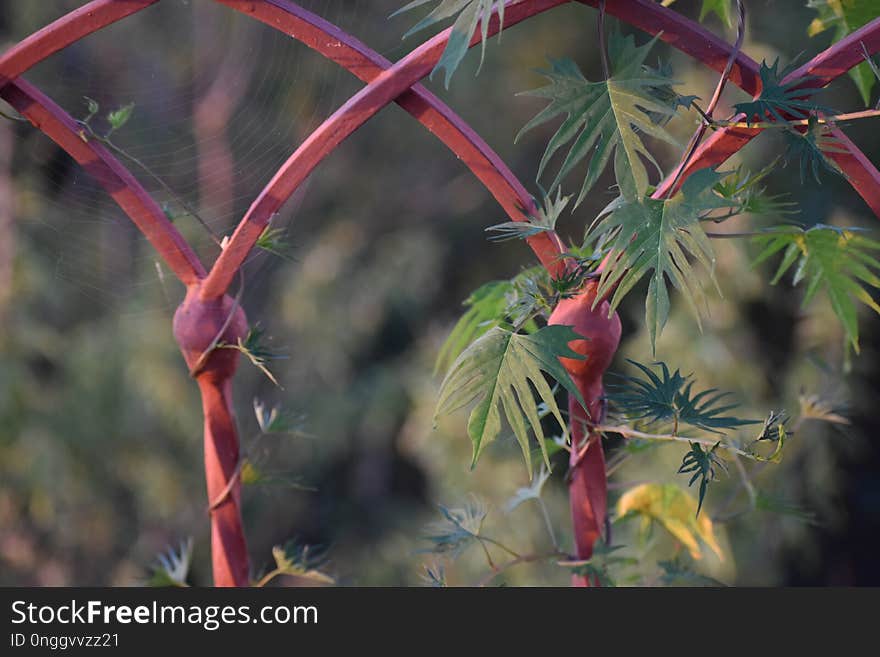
left=0, top=80, right=205, bottom=285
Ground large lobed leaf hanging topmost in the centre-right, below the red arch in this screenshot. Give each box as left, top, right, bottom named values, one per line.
left=517, top=32, right=678, bottom=207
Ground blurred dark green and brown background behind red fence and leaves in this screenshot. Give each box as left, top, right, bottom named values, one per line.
left=0, top=0, right=880, bottom=586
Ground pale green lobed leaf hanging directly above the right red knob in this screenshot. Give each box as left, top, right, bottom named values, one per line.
left=587, top=164, right=731, bottom=349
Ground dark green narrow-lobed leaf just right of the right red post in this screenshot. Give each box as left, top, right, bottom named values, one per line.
left=607, top=360, right=759, bottom=434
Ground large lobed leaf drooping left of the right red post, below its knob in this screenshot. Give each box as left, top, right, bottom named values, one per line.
left=435, top=326, right=584, bottom=478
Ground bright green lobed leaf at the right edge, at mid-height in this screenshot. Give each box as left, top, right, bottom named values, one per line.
left=754, top=224, right=880, bottom=353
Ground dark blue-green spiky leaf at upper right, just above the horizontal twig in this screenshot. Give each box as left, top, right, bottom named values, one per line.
left=733, top=58, right=834, bottom=123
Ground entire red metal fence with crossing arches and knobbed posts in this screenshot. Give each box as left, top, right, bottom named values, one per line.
left=0, top=0, right=880, bottom=586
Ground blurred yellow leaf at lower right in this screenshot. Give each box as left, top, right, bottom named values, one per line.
left=617, top=484, right=724, bottom=561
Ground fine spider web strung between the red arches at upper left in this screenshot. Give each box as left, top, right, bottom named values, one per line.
left=4, top=0, right=404, bottom=314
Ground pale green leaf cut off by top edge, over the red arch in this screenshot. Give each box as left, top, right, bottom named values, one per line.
left=391, top=0, right=505, bottom=89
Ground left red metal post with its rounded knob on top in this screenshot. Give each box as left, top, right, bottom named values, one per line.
left=174, top=285, right=250, bottom=586
